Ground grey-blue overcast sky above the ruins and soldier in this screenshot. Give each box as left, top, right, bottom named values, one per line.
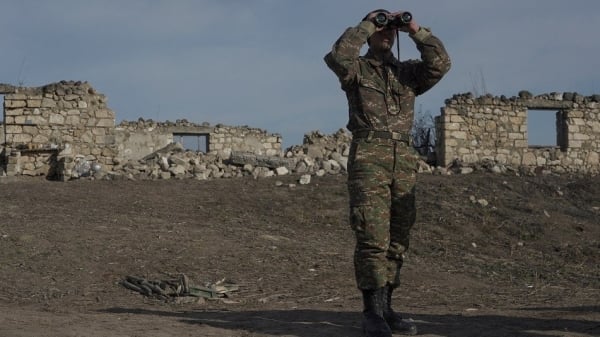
left=0, top=0, right=600, bottom=147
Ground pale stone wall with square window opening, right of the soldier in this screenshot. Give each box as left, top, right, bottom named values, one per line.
left=436, top=91, right=600, bottom=174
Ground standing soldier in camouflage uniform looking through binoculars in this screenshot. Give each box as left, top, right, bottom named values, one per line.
left=325, top=10, right=450, bottom=337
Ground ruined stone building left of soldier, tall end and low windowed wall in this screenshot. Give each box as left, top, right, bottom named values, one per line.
left=0, top=81, right=281, bottom=179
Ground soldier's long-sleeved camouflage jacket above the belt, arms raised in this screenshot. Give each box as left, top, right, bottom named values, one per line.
left=325, top=21, right=450, bottom=133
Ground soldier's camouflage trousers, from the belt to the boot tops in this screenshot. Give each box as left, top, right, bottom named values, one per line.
left=348, top=139, right=418, bottom=289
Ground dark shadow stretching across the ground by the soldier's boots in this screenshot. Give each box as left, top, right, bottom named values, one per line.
left=103, top=306, right=600, bottom=337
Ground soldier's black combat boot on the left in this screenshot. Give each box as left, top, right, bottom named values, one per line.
left=362, top=287, right=392, bottom=337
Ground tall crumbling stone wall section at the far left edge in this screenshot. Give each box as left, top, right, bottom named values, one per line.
left=0, top=81, right=117, bottom=177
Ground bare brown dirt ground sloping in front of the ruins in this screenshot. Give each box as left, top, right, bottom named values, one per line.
left=0, top=174, right=600, bottom=337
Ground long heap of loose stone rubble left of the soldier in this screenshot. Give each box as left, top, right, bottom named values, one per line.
left=89, top=129, right=352, bottom=181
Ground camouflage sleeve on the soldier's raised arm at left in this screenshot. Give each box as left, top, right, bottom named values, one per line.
left=325, top=21, right=375, bottom=90
